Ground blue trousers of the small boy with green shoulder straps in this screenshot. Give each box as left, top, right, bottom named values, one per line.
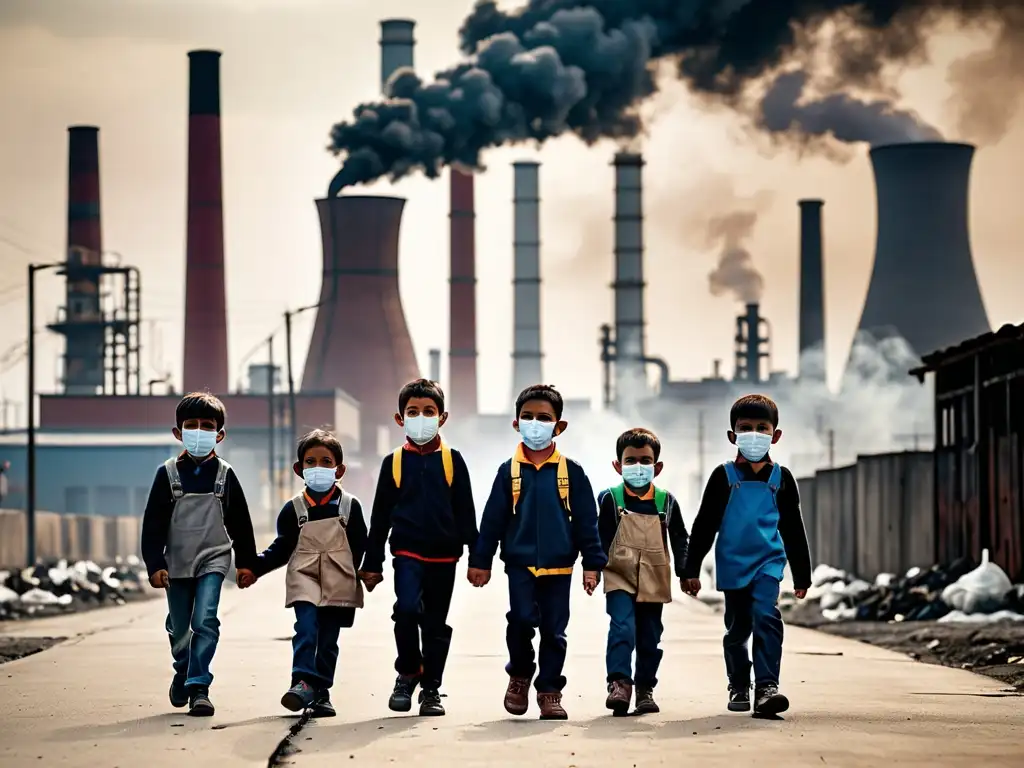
left=605, top=590, right=665, bottom=690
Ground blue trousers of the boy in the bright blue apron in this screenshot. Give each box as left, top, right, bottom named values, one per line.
left=723, top=574, right=782, bottom=688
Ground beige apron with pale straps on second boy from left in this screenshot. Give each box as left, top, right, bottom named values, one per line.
left=285, top=490, right=362, bottom=608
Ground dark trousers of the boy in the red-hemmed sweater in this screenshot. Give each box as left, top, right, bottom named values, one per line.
left=391, top=557, right=456, bottom=690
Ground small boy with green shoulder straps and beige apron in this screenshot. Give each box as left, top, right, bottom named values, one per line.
left=597, top=429, right=687, bottom=716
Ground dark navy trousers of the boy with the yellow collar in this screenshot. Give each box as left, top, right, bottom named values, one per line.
left=505, top=565, right=572, bottom=693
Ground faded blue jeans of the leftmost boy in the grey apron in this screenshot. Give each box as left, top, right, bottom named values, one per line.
left=165, top=573, right=224, bottom=688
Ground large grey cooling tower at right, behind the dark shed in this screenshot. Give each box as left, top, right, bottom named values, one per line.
left=858, top=141, right=991, bottom=355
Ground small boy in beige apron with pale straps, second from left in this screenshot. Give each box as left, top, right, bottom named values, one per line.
left=249, top=429, right=367, bottom=717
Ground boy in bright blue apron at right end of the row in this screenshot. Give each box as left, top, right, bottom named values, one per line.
left=683, top=394, right=811, bottom=716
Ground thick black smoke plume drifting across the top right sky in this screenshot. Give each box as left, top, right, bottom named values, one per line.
left=329, top=0, right=1021, bottom=195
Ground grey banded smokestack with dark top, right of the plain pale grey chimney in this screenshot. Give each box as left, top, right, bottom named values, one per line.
left=612, top=153, right=647, bottom=410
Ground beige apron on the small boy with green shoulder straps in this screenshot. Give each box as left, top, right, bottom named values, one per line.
left=604, top=509, right=672, bottom=603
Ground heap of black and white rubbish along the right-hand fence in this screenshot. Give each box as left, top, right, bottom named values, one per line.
left=807, top=550, right=1024, bottom=623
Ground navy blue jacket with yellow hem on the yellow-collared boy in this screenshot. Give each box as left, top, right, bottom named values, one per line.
left=469, top=451, right=608, bottom=575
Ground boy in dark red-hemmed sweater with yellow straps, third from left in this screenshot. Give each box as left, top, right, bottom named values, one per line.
left=359, top=379, right=477, bottom=716
